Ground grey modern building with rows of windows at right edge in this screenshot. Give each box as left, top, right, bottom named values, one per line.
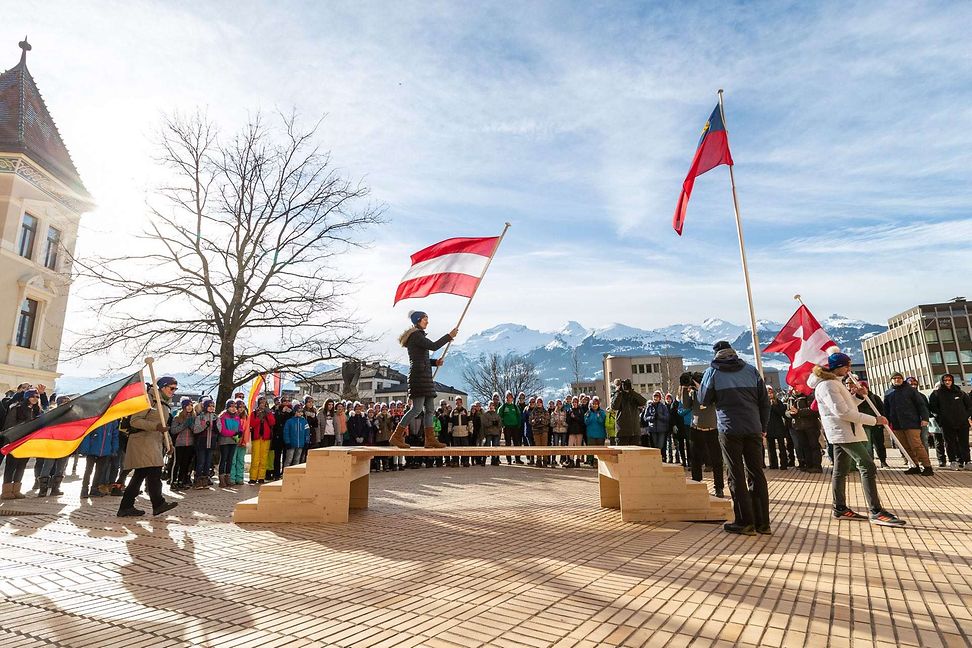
left=861, top=297, right=972, bottom=391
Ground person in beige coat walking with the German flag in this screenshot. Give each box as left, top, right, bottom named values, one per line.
left=117, top=376, right=179, bottom=517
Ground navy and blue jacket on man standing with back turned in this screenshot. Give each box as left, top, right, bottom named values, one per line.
left=699, top=354, right=769, bottom=436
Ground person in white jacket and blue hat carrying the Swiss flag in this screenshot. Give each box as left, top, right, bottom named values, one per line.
left=807, top=349, right=905, bottom=526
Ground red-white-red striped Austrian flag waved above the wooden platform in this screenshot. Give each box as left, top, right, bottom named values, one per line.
left=395, top=236, right=502, bottom=304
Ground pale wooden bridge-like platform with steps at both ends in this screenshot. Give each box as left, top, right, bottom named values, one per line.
left=233, top=446, right=732, bottom=523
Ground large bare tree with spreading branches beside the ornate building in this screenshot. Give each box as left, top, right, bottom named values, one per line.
left=66, top=113, right=381, bottom=402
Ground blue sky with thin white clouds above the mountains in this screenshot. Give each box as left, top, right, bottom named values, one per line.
left=0, top=0, right=972, bottom=374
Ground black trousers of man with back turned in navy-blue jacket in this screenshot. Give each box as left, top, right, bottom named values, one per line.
left=719, top=434, right=769, bottom=528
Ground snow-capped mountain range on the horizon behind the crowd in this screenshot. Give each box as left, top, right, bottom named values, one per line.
left=436, top=314, right=886, bottom=392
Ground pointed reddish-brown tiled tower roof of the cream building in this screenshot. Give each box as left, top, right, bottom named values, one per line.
left=0, top=38, right=90, bottom=198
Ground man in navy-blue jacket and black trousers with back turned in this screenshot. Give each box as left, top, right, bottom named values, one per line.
left=699, top=340, right=771, bottom=535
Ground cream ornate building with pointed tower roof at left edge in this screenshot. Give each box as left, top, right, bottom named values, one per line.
left=0, top=40, right=94, bottom=391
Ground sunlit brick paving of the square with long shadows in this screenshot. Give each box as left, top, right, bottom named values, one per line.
left=0, top=466, right=972, bottom=648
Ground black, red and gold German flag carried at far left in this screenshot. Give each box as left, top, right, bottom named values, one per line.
left=0, top=371, right=150, bottom=459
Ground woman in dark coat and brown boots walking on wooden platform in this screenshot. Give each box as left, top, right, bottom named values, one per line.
left=388, top=311, right=459, bottom=448
